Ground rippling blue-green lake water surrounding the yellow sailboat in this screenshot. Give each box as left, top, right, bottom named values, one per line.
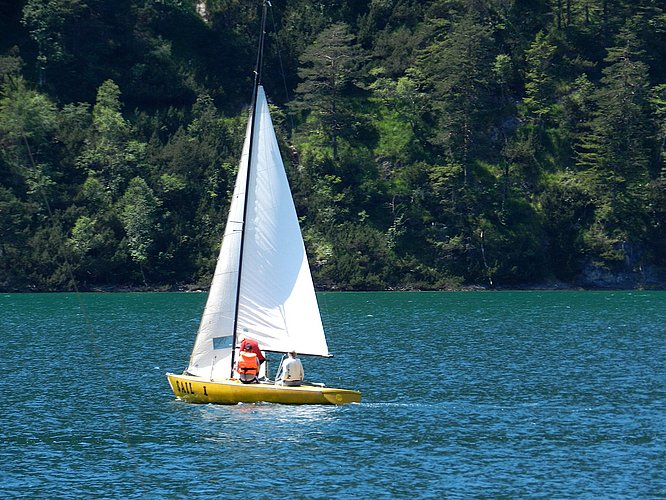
left=0, top=291, right=666, bottom=498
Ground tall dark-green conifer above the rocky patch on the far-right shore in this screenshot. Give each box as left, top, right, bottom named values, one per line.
left=578, top=26, right=654, bottom=257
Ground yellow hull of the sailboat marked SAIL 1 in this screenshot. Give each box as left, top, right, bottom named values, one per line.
left=166, top=373, right=361, bottom=405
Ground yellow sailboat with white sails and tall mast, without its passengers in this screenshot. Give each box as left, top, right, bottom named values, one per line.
left=166, top=4, right=361, bottom=405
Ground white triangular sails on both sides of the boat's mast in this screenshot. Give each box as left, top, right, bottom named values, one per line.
left=187, top=86, right=329, bottom=379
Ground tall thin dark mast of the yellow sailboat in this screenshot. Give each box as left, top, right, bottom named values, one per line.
left=229, top=0, right=270, bottom=378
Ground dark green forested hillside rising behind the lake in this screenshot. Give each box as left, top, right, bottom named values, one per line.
left=0, top=0, right=666, bottom=290
